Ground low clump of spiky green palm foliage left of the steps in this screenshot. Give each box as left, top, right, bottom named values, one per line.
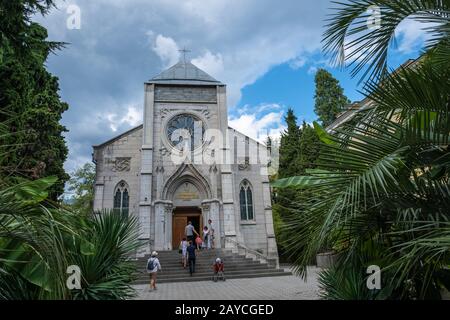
left=0, top=123, right=139, bottom=300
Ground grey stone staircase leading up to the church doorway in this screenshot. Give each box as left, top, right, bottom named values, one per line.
left=136, top=249, right=291, bottom=284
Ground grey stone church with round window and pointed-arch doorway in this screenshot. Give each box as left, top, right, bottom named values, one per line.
left=93, top=61, right=278, bottom=261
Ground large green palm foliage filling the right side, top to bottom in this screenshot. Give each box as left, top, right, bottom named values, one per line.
left=274, top=0, right=450, bottom=299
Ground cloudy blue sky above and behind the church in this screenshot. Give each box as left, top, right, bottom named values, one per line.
left=34, top=0, right=425, bottom=172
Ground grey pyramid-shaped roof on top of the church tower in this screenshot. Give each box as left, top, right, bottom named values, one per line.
left=148, top=61, right=223, bottom=86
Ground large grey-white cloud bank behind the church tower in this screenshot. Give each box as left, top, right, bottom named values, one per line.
left=35, top=0, right=330, bottom=172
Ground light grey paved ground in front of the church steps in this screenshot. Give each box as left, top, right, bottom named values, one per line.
left=134, top=267, right=320, bottom=300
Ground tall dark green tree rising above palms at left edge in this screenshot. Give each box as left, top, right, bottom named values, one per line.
left=0, top=1, right=68, bottom=200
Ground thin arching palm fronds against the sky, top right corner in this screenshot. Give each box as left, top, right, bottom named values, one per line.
left=323, top=0, right=450, bottom=82
